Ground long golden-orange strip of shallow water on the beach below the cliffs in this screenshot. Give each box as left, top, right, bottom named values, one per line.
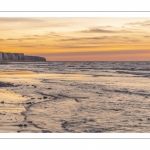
left=0, top=71, right=92, bottom=84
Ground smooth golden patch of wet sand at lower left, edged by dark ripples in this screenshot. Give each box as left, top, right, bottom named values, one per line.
left=0, top=89, right=27, bottom=132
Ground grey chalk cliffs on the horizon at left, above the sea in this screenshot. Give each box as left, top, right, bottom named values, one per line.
left=0, top=52, right=46, bottom=62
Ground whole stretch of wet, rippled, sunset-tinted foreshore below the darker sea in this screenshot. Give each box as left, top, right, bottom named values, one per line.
left=0, top=63, right=150, bottom=133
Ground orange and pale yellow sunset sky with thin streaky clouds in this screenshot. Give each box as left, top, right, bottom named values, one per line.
left=0, top=17, right=150, bottom=61
